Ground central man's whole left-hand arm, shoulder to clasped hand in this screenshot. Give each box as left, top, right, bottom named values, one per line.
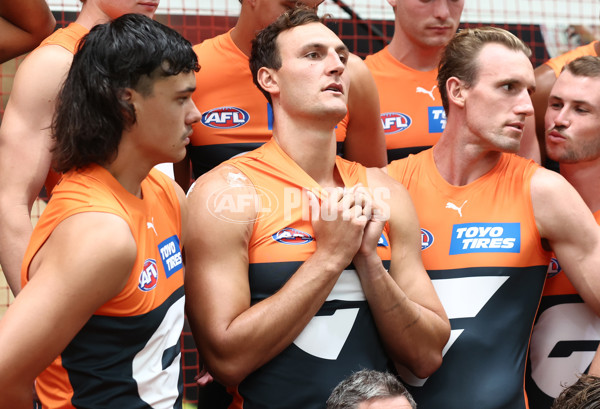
left=185, top=166, right=366, bottom=385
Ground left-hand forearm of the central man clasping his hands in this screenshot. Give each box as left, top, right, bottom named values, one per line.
left=196, top=252, right=343, bottom=385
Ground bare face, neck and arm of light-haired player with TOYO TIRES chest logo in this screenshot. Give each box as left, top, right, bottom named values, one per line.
left=434, top=44, right=600, bottom=366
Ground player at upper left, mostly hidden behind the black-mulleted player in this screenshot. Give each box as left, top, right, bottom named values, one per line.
left=0, top=0, right=158, bottom=295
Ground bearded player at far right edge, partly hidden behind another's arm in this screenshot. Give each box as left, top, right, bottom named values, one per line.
left=527, top=56, right=600, bottom=409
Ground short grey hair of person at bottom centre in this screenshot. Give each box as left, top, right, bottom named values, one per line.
left=327, top=369, right=417, bottom=409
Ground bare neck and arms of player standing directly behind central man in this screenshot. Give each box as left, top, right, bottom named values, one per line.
left=173, top=0, right=387, bottom=190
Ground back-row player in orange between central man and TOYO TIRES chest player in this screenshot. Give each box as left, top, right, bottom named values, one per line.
left=340, top=0, right=464, bottom=162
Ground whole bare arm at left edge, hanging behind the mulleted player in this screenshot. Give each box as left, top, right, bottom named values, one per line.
left=0, top=46, right=73, bottom=295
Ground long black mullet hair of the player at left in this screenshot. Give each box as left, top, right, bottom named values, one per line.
left=52, top=14, right=199, bottom=172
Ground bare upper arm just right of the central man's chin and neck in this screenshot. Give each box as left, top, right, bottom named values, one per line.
left=340, top=54, right=387, bottom=167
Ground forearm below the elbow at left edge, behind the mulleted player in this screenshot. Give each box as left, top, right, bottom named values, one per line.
left=0, top=204, right=33, bottom=296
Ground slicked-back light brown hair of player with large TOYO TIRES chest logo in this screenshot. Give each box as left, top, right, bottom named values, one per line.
left=437, top=27, right=531, bottom=114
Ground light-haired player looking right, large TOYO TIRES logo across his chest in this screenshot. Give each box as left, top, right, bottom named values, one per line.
left=388, top=27, right=600, bottom=409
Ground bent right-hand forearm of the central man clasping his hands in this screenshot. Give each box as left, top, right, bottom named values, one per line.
left=355, top=258, right=450, bottom=378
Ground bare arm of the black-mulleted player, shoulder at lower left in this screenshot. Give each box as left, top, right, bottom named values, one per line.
left=0, top=213, right=136, bottom=409
